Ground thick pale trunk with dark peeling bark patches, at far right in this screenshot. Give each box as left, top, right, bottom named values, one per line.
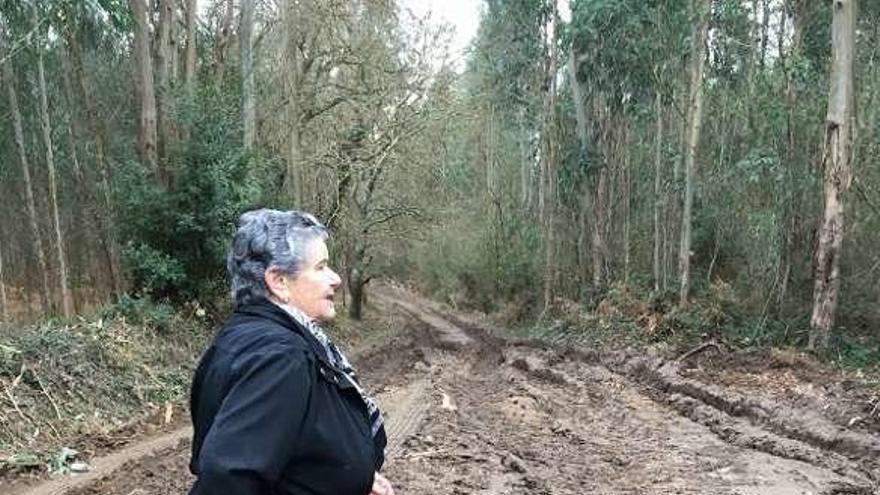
left=809, top=0, right=856, bottom=350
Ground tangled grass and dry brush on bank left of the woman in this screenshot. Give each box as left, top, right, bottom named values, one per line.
left=0, top=296, right=211, bottom=472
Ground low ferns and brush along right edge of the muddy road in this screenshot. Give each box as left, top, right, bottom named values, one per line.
left=495, top=283, right=880, bottom=375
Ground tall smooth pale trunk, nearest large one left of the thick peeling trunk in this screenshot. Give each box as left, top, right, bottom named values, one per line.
left=678, top=0, right=712, bottom=307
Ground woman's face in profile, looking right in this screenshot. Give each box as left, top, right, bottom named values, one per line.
left=285, top=238, right=342, bottom=321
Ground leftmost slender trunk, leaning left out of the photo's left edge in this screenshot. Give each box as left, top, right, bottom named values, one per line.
left=0, top=37, right=51, bottom=313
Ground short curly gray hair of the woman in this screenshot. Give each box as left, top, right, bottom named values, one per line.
left=226, top=209, right=329, bottom=305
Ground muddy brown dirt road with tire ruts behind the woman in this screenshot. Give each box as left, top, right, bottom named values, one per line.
left=20, top=289, right=880, bottom=495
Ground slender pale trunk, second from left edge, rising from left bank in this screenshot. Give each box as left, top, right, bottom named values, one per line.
left=31, top=3, right=74, bottom=318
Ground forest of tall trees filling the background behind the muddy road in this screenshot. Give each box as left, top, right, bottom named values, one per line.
left=0, top=0, right=880, bottom=358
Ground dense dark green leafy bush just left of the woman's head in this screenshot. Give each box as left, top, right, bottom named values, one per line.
left=116, top=91, right=277, bottom=302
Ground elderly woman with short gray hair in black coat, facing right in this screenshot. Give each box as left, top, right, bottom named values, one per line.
left=190, top=210, right=394, bottom=495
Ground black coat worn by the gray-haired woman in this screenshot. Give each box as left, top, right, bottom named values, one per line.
left=190, top=301, right=386, bottom=495
